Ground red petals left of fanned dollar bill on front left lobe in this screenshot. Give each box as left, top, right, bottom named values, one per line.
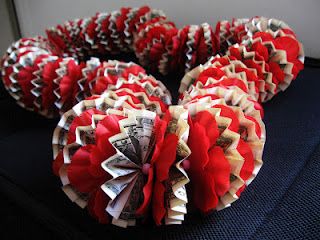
left=57, top=113, right=123, bottom=223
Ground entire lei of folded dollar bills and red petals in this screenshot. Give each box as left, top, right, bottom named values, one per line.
left=1, top=6, right=304, bottom=227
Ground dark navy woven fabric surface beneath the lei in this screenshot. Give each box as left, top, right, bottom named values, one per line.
left=0, top=65, right=320, bottom=239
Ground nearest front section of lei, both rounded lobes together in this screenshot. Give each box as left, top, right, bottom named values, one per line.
left=53, top=72, right=265, bottom=227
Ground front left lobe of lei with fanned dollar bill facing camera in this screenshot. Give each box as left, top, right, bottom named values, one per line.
left=53, top=96, right=190, bottom=227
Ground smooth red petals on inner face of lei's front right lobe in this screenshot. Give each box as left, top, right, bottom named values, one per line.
left=188, top=111, right=230, bottom=212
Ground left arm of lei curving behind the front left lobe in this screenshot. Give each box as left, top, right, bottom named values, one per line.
left=3, top=51, right=171, bottom=117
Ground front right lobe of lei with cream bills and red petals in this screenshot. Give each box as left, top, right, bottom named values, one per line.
left=184, top=91, right=265, bottom=212
